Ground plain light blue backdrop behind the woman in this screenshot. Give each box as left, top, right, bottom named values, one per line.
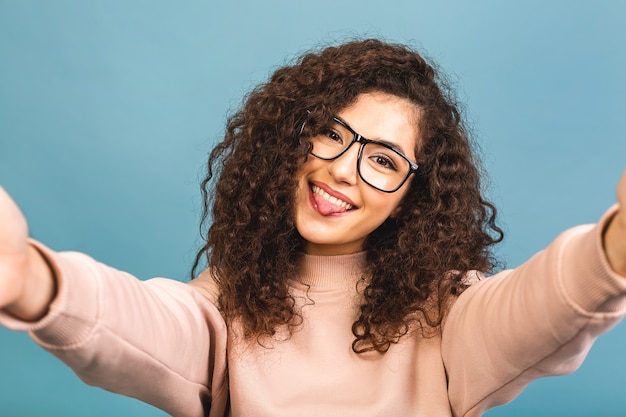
left=0, top=0, right=626, bottom=417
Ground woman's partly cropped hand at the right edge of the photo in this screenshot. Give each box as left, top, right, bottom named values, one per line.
left=604, top=171, right=626, bottom=277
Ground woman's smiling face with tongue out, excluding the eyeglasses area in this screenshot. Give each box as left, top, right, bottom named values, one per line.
left=295, top=92, right=419, bottom=255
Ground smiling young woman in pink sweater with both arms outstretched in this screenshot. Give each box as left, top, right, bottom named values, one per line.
left=0, top=40, right=626, bottom=417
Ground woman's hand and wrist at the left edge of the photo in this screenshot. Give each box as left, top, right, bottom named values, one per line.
left=0, top=187, right=55, bottom=320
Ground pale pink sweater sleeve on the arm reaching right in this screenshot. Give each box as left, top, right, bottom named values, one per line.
left=442, top=209, right=626, bottom=417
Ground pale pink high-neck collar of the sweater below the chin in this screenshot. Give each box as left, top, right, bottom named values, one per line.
left=297, top=252, right=366, bottom=291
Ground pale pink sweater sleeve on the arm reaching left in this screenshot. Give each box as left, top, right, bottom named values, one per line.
left=0, top=242, right=228, bottom=417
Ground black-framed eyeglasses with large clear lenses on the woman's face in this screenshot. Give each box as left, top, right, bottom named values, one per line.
left=309, top=117, right=418, bottom=193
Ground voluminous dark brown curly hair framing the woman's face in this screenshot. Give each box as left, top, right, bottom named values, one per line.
left=192, top=39, right=503, bottom=353
